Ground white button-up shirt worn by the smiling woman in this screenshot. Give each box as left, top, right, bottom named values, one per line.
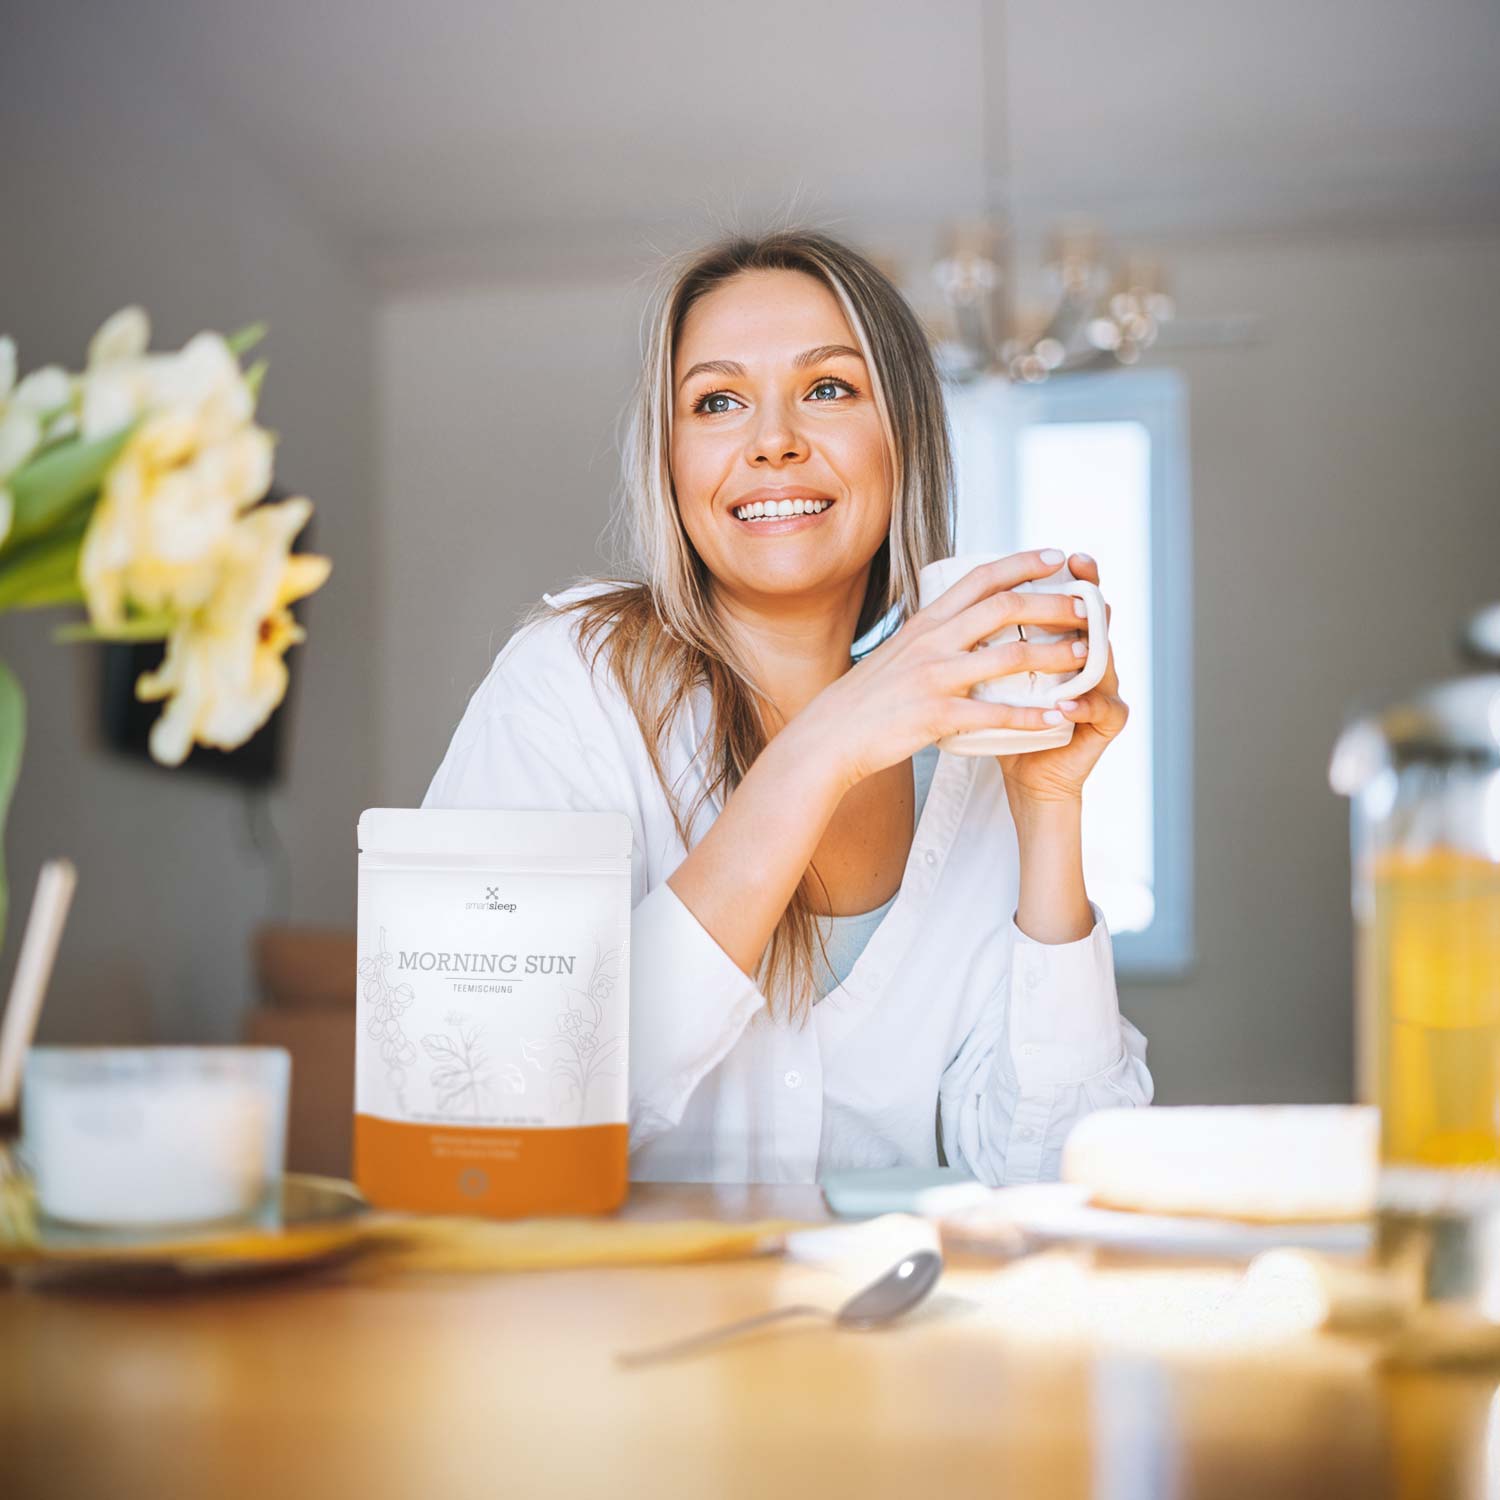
left=422, top=584, right=1152, bottom=1185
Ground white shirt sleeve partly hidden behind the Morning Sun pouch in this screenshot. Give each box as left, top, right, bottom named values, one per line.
left=422, top=674, right=765, bottom=1151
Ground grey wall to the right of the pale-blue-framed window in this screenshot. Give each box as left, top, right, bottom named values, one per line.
left=1127, top=237, right=1500, bottom=1103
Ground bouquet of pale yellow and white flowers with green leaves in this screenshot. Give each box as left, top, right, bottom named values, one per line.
left=0, top=306, right=330, bottom=939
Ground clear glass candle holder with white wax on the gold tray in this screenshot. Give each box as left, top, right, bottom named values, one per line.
left=21, top=1047, right=291, bottom=1230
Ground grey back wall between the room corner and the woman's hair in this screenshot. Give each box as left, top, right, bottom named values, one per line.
left=377, top=281, right=639, bottom=806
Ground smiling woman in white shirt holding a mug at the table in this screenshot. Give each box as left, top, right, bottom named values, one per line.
left=423, top=230, right=1152, bottom=1184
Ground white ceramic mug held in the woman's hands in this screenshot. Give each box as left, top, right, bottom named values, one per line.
left=918, top=552, right=1110, bottom=755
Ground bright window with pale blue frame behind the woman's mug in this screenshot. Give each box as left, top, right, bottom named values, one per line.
left=948, top=371, right=1193, bottom=975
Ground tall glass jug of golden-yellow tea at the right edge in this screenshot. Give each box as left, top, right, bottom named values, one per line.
left=1329, top=606, right=1500, bottom=1316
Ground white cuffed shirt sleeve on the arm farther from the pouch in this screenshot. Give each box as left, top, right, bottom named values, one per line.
left=939, top=906, right=1154, bottom=1187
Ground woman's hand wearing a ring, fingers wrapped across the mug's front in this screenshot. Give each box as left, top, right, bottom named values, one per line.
left=782, top=552, right=1083, bottom=788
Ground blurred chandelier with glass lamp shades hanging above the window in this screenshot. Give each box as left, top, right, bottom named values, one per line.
left=932, top=218, right=1173, bottom=384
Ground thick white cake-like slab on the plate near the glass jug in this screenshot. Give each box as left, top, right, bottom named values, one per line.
left=1062, top=1104, right=1380, bottom=1224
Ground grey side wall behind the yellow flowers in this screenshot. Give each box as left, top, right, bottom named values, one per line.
left=0, top=8, right=377, bottom=1041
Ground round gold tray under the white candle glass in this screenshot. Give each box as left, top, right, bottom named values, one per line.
left=0, top=1172, right=371, bottom=1283
